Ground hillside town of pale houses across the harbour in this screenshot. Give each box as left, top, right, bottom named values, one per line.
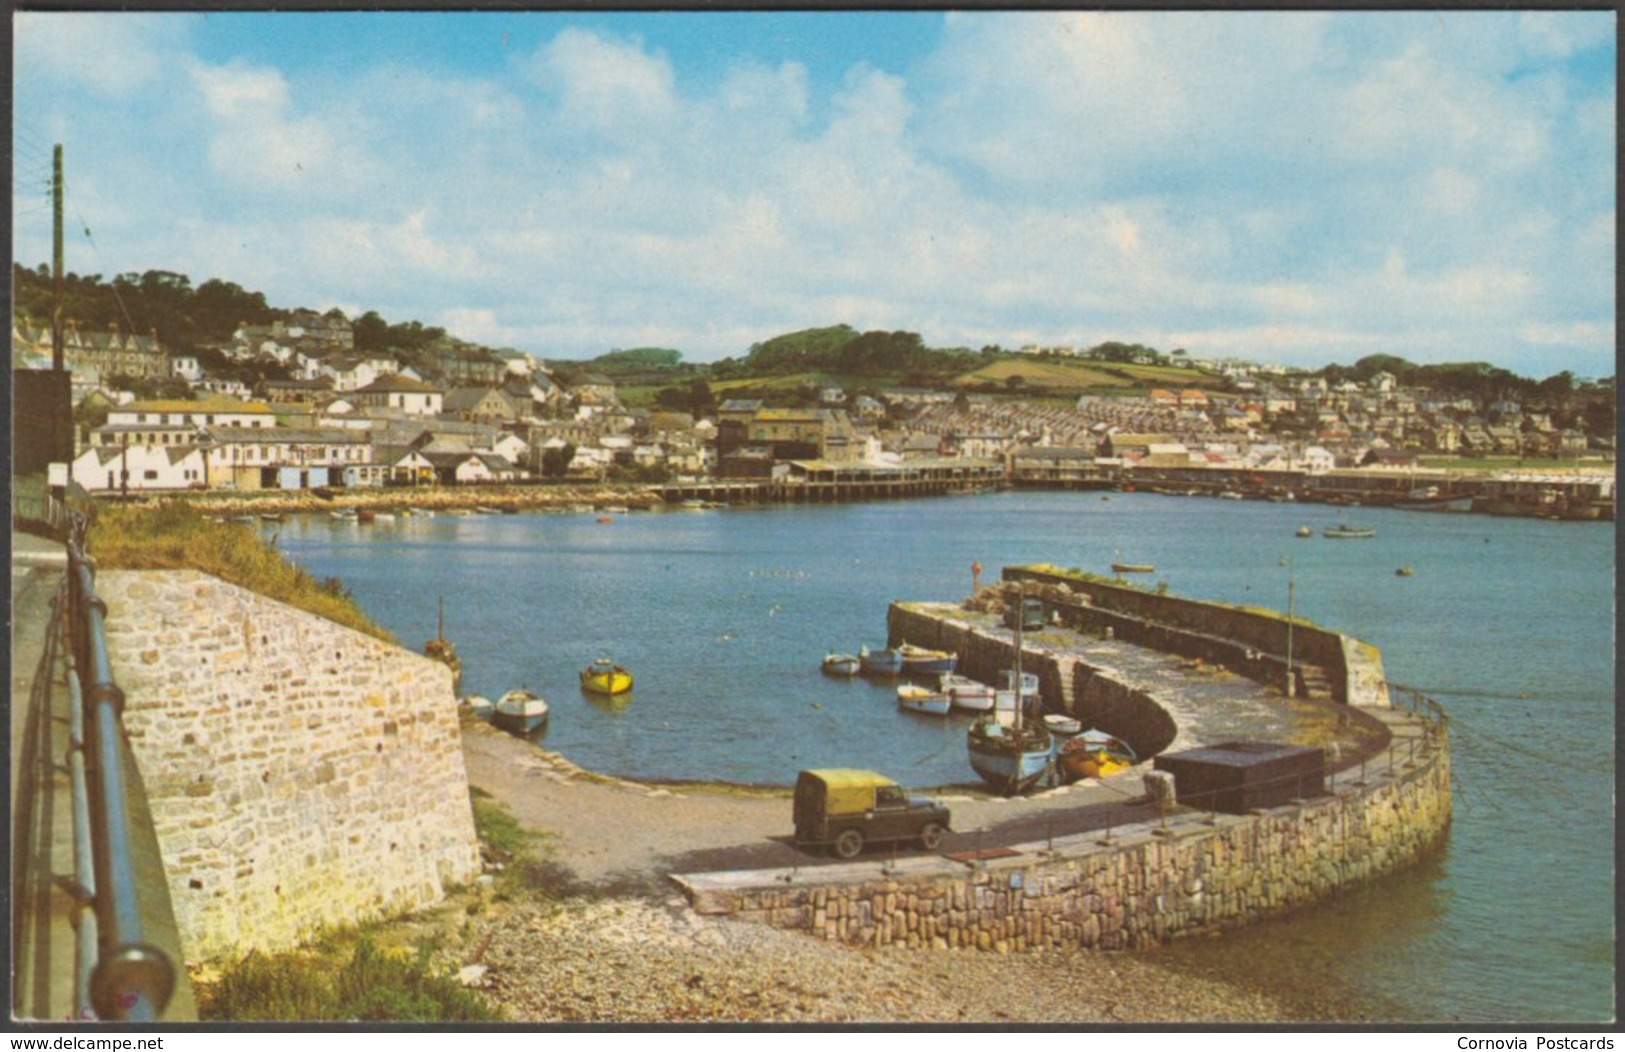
left=11, top=311, right=1614, bottom=494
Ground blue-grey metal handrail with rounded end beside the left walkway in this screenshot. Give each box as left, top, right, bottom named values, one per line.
left=67, top=514, right=176, bottom=1021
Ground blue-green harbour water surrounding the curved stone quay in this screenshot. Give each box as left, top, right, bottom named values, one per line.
left=278, top=493, right=1615, bottom=1023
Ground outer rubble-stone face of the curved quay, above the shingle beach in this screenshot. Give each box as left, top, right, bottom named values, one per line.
left=686, top=737, right=1451, bottom=953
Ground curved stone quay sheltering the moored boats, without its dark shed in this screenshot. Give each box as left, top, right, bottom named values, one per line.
left=673, top=567, right=1451, bottom=953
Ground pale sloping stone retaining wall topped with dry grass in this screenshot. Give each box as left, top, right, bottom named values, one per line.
left=96, top=571, right=479, bottom=959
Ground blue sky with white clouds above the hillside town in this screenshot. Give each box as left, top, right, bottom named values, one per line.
left=13, top=11, right=1617, bottom=377
